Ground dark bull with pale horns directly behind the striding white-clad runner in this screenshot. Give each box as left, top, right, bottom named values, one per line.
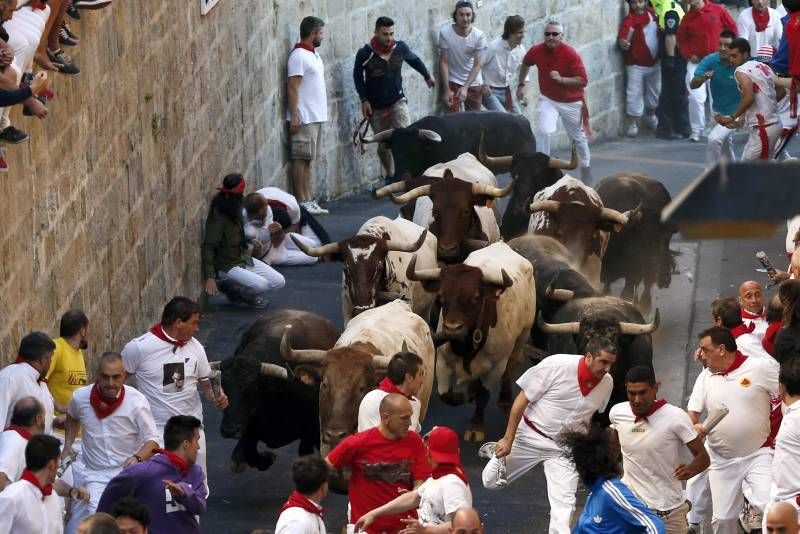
left=538, top=297, right=659, bottom=423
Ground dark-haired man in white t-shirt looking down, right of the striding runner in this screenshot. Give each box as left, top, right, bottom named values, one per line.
left=609, top=366, right=710, bottom=534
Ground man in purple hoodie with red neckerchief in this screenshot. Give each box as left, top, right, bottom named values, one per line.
left=97, top=415, right=208, bottom=534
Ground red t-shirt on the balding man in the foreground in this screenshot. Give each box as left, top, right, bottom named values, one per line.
left=328, top=427, right=431, bottom=534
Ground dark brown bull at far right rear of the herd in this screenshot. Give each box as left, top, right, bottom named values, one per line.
left=597, top=173, right=678, bottom=313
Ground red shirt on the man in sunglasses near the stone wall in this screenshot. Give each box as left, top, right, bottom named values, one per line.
left=522, top=43, right=589, bottom=102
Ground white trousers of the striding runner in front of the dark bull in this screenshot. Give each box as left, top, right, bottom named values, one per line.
left=482, top=421, right=578, bottom=534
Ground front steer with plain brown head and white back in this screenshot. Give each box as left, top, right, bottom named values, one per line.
left=281, top=298, right=435, bottom=493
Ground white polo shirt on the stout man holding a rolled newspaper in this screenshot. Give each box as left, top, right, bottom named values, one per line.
left=687, top=358, right=778, bottom=459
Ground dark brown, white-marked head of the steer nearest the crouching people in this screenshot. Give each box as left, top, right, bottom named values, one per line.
left=291, top=230, right=428, bottom=317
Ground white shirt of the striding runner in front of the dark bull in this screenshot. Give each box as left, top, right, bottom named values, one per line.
left=517, top=354, right=614, bottom=438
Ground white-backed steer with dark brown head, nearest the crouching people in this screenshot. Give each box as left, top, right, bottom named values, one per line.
left=292, top=216, right=436, bottom=324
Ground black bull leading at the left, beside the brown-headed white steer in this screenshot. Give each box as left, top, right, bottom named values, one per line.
left=220, top=310, right=339, bottom=473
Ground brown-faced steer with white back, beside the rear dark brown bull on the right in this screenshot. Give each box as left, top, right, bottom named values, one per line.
left=528, top=176, right=628, bottom=288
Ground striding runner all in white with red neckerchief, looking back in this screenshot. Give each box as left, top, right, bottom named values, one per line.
left=480, top=338, right=617, bottom=534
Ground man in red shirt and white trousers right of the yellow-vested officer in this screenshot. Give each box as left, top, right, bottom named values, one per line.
left=678, top=0, right=739, bottom=143
